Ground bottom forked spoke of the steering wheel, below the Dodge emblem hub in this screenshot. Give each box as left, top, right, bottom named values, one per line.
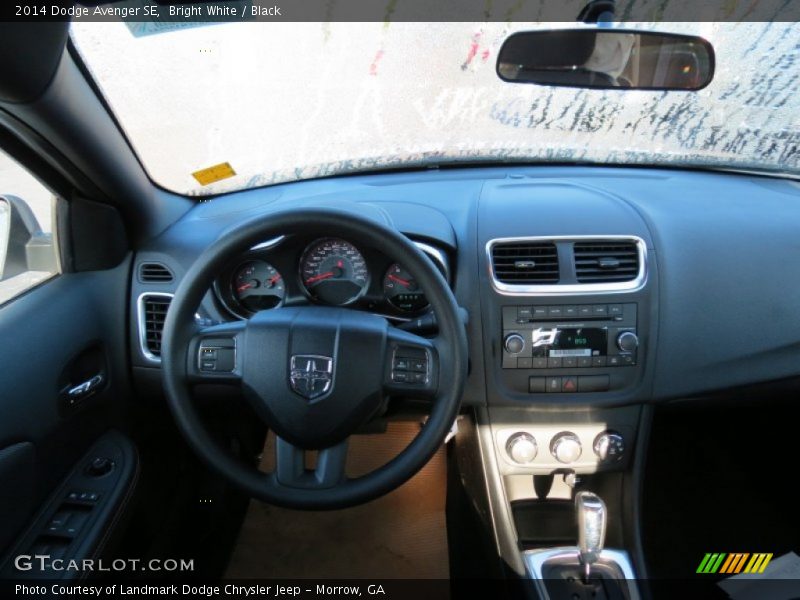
left=275, top=437, right=347, bottom=489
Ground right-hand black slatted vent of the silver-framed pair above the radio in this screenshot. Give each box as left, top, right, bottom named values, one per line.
left=575, top=240, right=641, bottom=283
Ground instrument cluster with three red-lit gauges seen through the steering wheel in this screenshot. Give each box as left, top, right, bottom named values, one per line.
left=214, top=236, right=450, bottom=321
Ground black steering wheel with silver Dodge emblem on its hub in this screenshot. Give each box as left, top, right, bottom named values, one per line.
left=161, top=207, right=467, bottom=509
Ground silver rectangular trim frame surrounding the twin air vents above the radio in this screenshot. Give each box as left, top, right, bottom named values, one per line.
left=486, top=235, right=648, bottom=296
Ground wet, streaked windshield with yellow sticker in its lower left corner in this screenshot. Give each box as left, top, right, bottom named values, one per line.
left=72, top=23, right=800, bottom=195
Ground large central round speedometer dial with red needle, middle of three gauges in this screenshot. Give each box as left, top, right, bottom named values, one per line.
left=300, top=238, right=369, bottom=306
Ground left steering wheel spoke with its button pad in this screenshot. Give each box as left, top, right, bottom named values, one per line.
left=186, top=321, right=246, bottom=384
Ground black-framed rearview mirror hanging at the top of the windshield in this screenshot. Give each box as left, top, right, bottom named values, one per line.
left=497, top=29, right=714, bottom=90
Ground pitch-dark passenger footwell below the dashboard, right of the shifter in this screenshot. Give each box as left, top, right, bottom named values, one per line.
left=643, top=393, right=800, bottom=598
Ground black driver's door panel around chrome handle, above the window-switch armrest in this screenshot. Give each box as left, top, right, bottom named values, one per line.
left=0, top=257, right=130, bottom=555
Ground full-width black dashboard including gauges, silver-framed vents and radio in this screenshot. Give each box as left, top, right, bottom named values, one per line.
left=130, top=166, right=800, bottom=410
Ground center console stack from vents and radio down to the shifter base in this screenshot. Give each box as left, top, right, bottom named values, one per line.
left=466, top=180, right=658, bottom=580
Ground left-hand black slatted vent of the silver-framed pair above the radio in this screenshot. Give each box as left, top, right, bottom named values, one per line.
left=492, top=242, right=559, bottom=285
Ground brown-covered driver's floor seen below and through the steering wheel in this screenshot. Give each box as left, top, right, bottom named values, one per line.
left=225, top=421, right=449, bottom=580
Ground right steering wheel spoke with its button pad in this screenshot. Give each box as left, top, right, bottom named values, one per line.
left=383, top=329, right=439, bottom=398
